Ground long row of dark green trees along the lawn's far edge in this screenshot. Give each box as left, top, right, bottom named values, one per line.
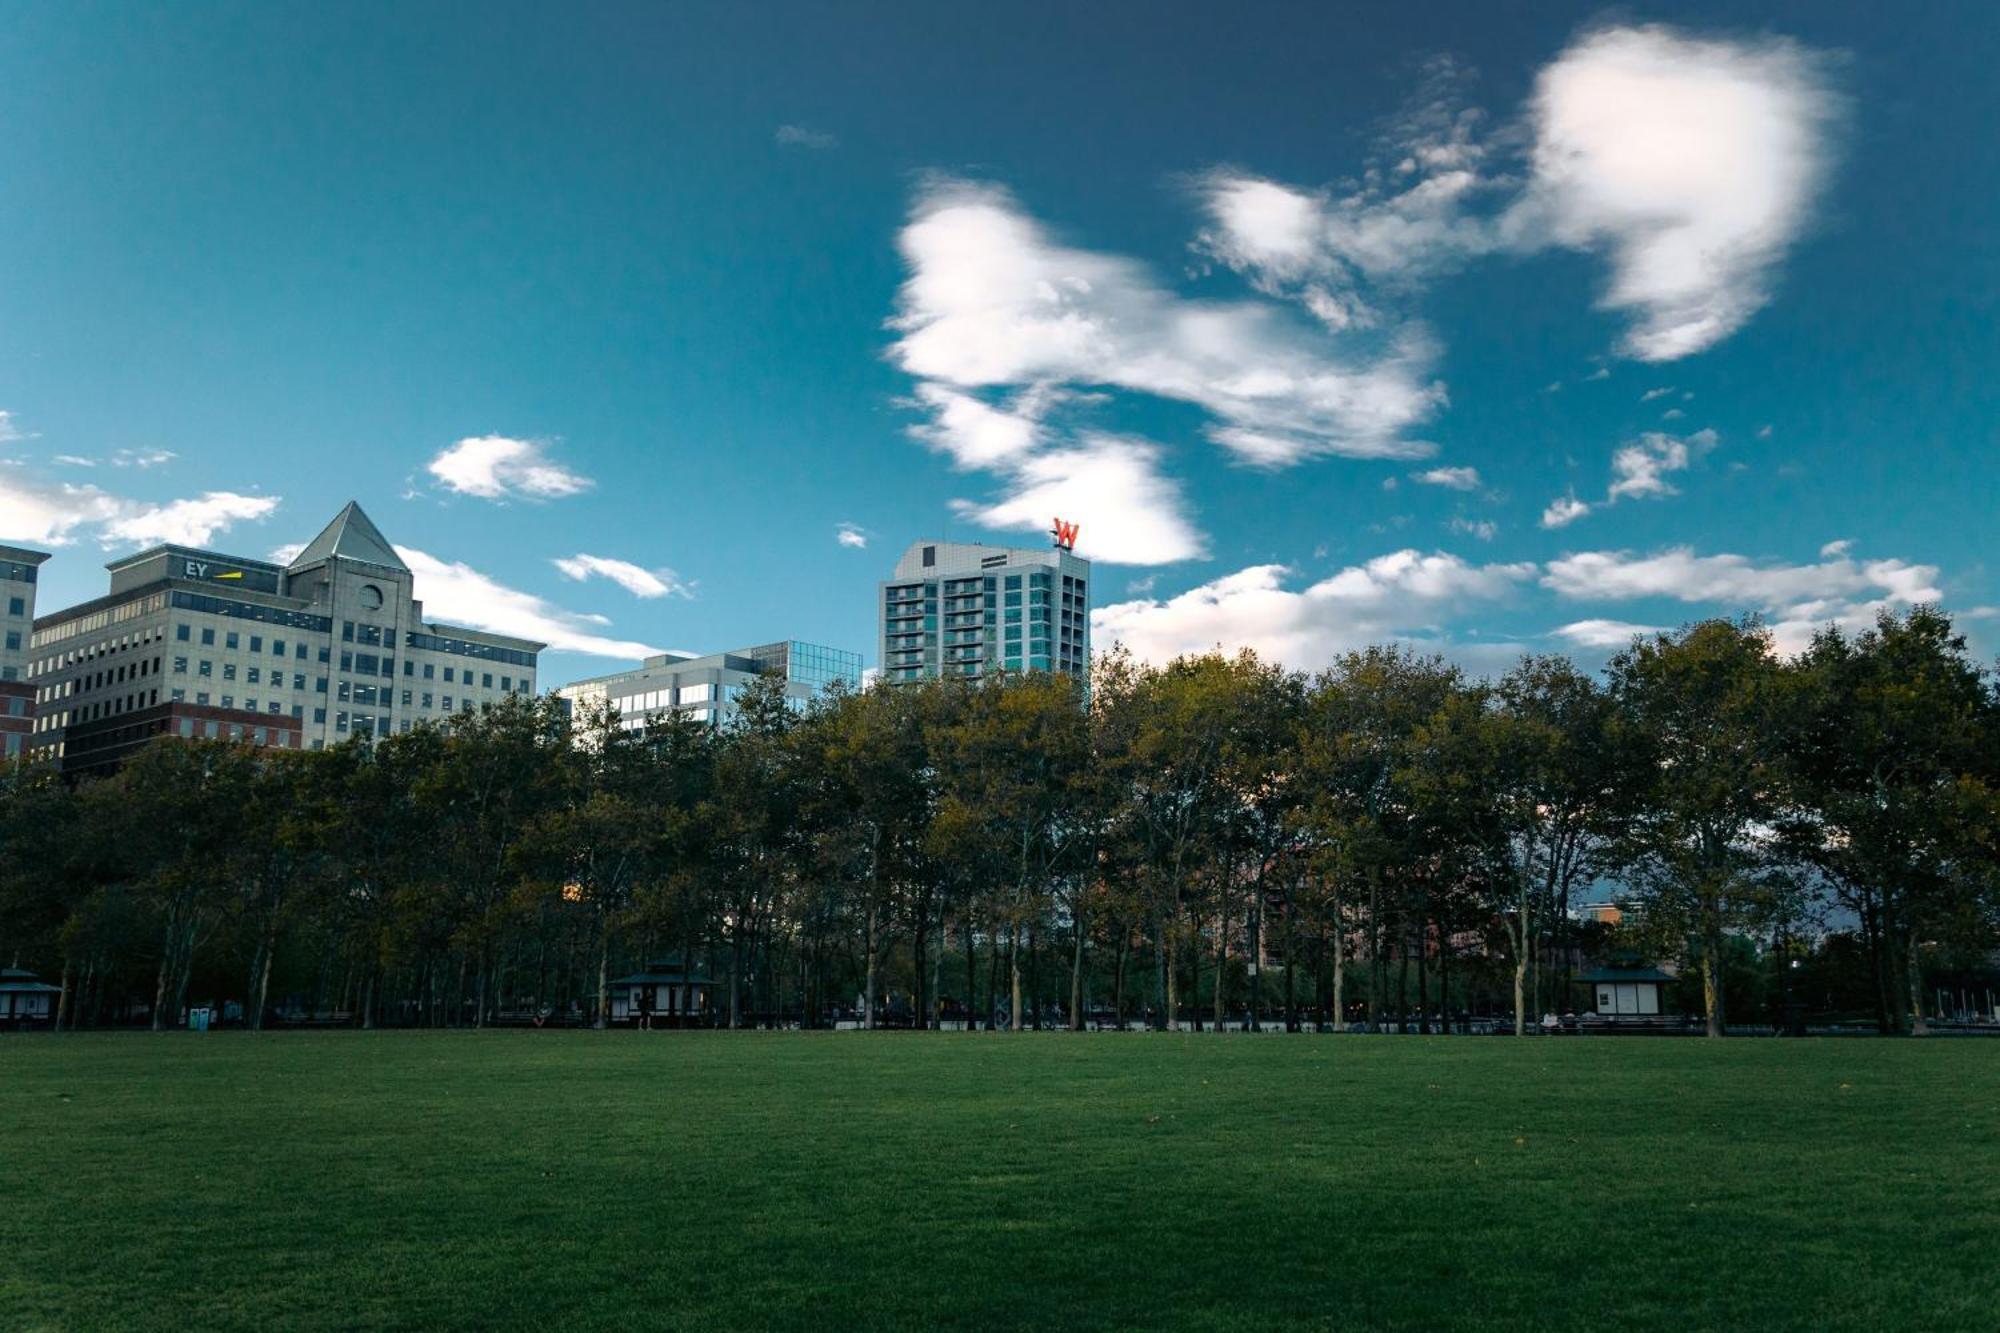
left=0, top=606, right=2000, bottom=1035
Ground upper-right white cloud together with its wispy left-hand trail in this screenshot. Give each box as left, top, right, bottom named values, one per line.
left=1198, top=26, right=1836, bottom=366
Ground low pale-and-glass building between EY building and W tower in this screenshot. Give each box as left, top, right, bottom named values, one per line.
left=556, top=638, right=862, bottom=731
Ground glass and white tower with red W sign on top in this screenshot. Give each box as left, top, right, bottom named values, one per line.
left=878, top=522, right=1090, bottom=683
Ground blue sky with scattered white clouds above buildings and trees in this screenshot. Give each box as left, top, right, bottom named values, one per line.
left=0, top=2, right=2000, bottom=685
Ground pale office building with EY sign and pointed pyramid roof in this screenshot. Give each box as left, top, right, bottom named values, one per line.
left=28, top=504, right=546, bottom=773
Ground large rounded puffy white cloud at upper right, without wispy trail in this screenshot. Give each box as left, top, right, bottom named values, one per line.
left=1506, top=26, right=1836, bottom=362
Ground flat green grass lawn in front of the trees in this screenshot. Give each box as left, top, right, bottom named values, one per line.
left=0, top=1033, right=2000, bottom=1333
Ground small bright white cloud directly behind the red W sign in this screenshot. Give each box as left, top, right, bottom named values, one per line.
left=954, top=432, right=1206, bottom=564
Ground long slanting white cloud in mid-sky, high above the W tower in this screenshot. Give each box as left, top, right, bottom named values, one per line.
left=890, top=180, right=1444, bottom=466
